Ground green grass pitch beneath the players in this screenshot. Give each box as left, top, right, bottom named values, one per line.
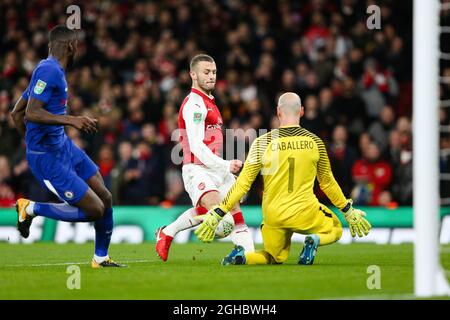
left=0, top=243, right=450, bottom=300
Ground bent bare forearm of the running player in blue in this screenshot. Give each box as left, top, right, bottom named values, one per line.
left=25, top=97, right=97, bottom=133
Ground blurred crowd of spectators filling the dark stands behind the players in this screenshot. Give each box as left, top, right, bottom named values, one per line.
left=0, top=0, right=450, bottom=206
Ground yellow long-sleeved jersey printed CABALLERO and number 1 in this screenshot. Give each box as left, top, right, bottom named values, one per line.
left=221, top=126, right=347, bottom=226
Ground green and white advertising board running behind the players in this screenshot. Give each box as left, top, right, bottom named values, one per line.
left=0, top=206, right=450, bottom=244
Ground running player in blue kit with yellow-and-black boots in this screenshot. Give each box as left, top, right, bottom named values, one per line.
left=11, top=25, right=122, bottom=268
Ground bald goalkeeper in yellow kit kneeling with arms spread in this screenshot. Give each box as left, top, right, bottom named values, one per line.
left=195, top=92, right=371, bottom=265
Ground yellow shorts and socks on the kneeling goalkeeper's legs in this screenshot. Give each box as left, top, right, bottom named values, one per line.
left=261, top=204, right=342, bottom=263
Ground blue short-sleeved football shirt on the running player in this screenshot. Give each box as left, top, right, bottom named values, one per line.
left=22, top=56, right=67, bottom=152
